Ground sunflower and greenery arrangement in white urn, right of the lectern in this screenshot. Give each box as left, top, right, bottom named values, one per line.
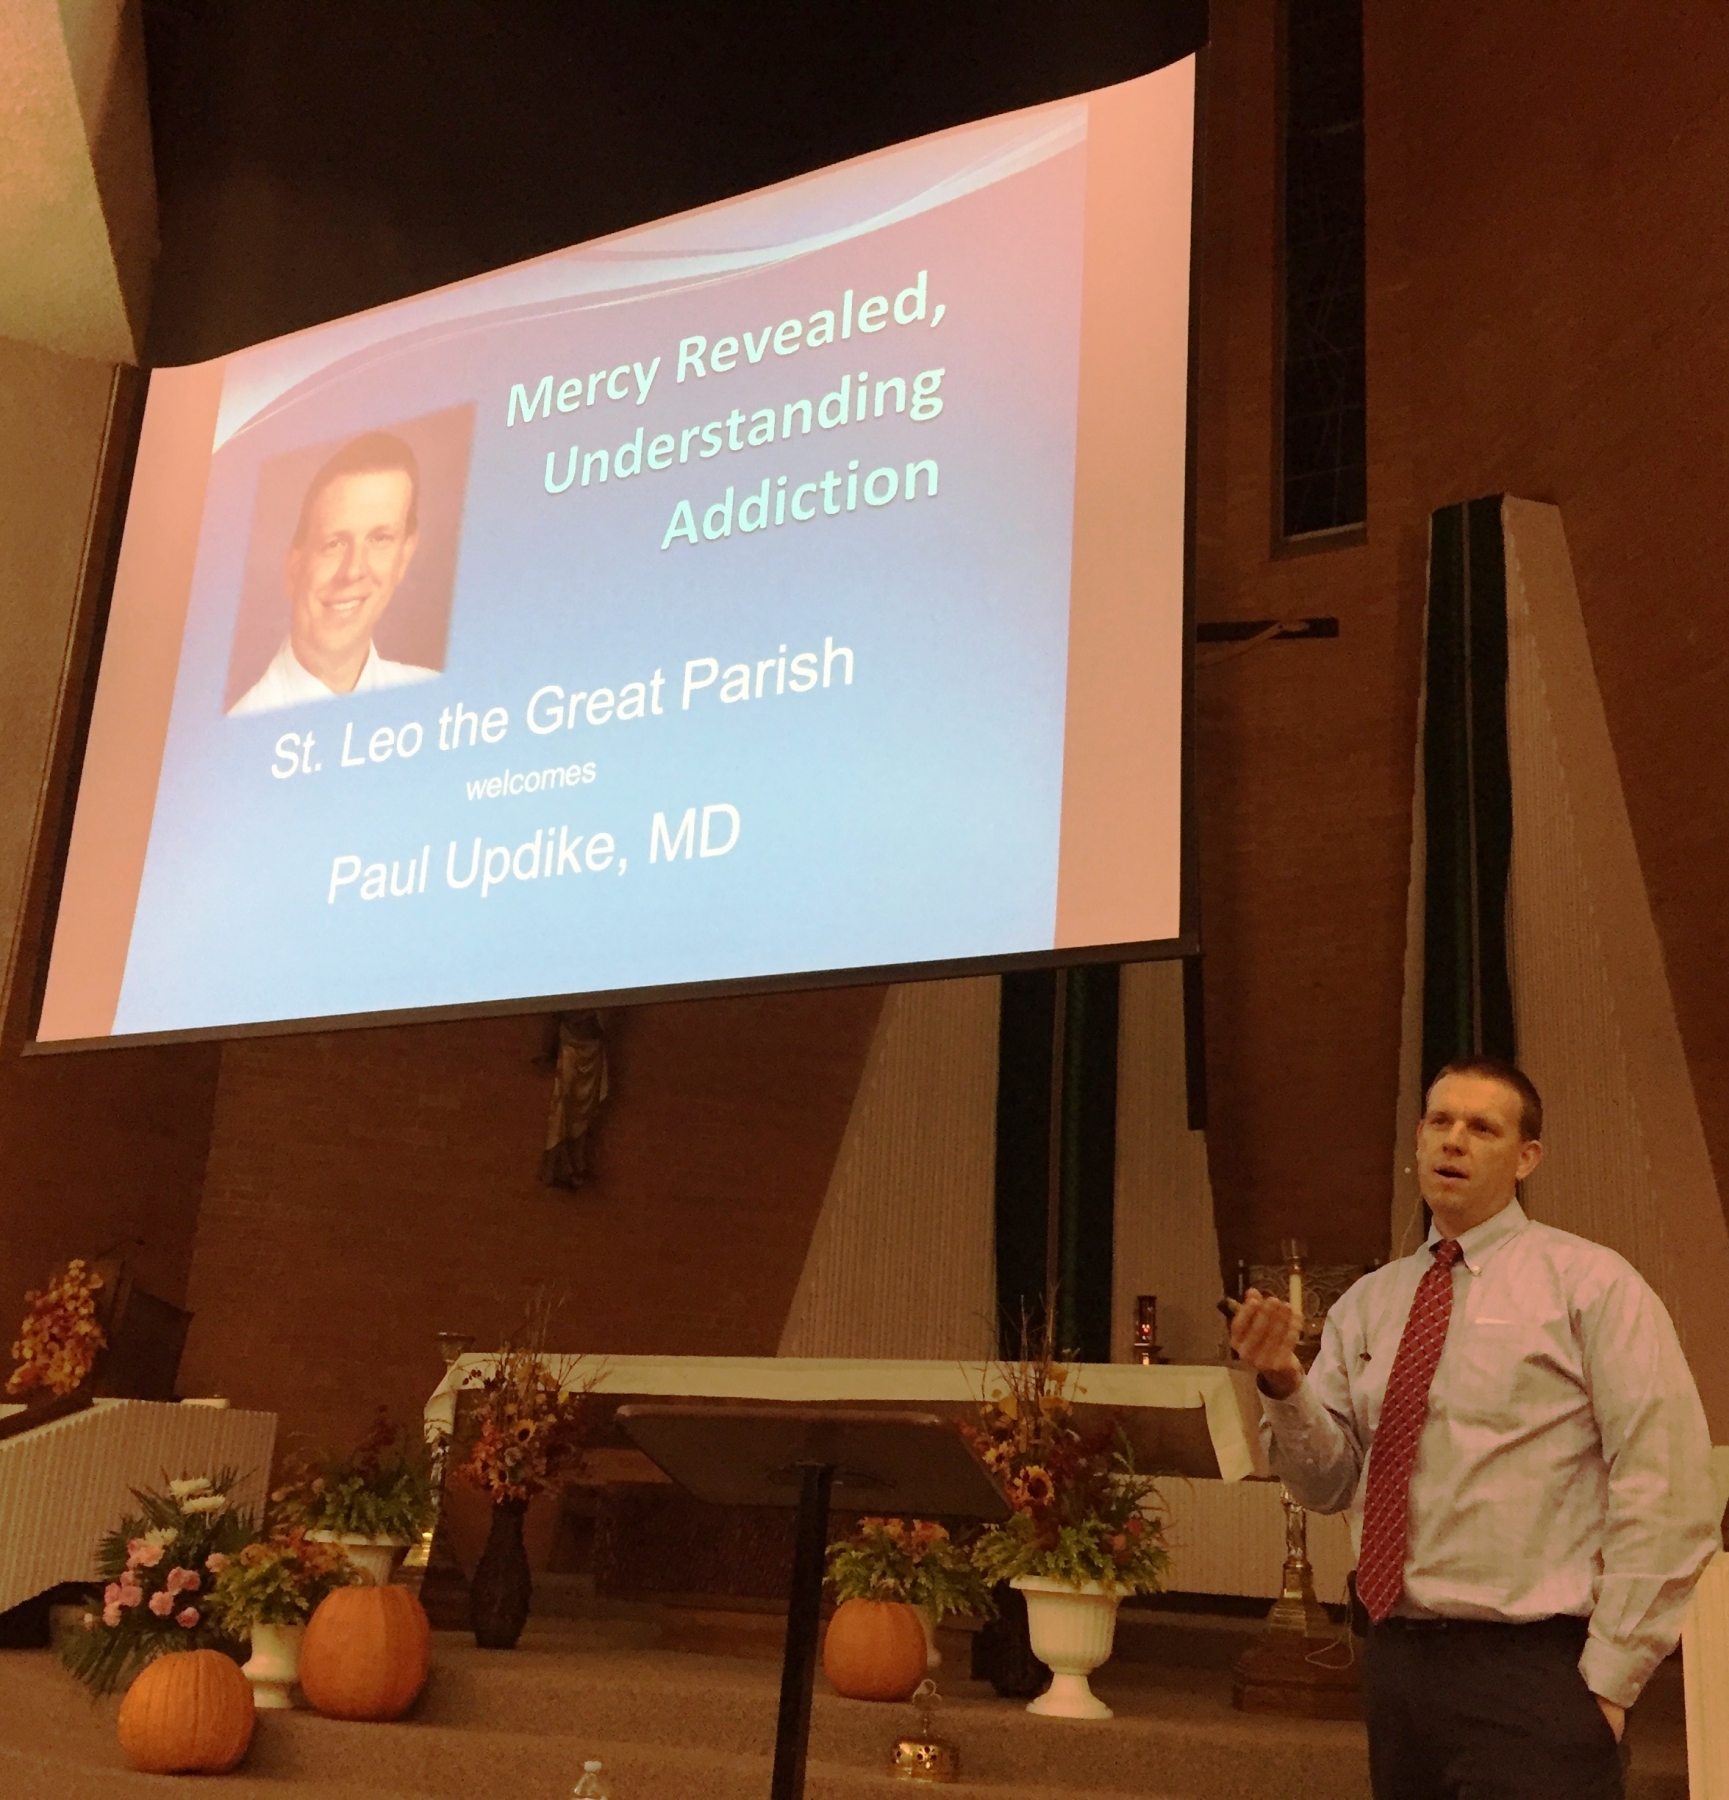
left=963, top=1341, right=1168, bottom=1593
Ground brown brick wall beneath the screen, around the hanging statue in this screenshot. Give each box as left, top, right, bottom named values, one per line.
left=182, top=988, right=882, bottom=1442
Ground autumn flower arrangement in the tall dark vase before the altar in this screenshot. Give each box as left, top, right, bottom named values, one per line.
left=452, top=1294, right=603, bottom=1507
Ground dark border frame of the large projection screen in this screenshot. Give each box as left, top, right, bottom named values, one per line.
left=20, top=63, right=1211, bottom=1057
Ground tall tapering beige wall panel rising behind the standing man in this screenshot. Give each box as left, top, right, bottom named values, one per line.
left=1502, top=499, right=1729, bottom=1444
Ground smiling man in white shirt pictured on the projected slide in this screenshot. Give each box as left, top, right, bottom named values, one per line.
left=228, top=432, right=437, bottom=718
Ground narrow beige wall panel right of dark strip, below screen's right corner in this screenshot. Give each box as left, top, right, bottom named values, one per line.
left=1110, top=963, right=1225, bottom=1360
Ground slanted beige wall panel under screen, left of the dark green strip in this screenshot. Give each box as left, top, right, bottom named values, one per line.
left=781, top=976, right=1002, bottom=1359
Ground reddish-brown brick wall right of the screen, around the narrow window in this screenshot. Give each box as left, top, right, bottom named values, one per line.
left=1195, top=0, right=1729, bottom=1267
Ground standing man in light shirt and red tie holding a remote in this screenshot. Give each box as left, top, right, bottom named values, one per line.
left=1231, top=1058, right=1718, bottom=1800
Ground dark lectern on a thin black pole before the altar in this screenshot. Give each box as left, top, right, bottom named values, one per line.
left=617, top=1404, right=1009, bottom=1800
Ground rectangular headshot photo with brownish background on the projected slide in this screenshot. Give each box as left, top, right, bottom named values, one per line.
left=223, top=405, right=475, bottom=718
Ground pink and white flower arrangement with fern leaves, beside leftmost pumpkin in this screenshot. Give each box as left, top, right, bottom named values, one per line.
left=61, top=1469, right=257, bottom=1694
